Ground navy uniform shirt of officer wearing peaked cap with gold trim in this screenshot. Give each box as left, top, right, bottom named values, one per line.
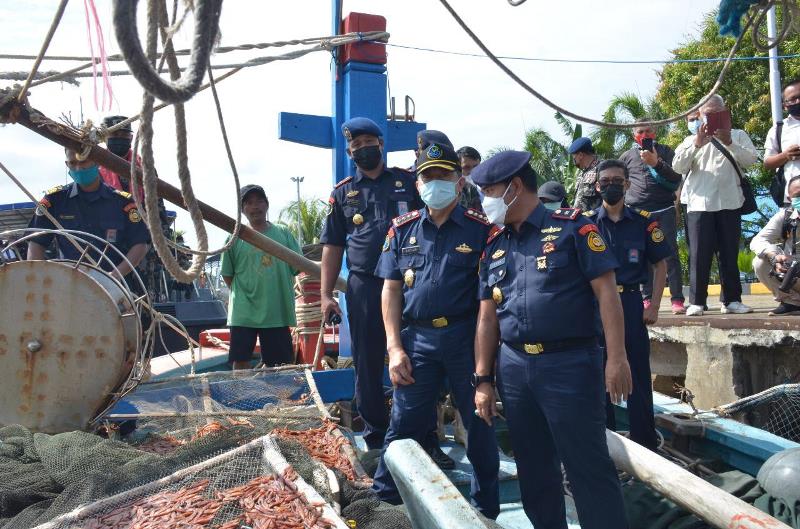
left=375, top=205, right=491, bottom=321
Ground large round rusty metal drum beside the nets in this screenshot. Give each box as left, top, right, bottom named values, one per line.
left=0, top=261, right=141, bottom=433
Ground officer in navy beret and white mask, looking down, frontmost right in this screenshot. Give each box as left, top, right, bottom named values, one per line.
left=472, top=151, right=631, bottom=529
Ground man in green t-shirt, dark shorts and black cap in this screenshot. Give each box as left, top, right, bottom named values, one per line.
left=222, top=185, right=300, bottom=369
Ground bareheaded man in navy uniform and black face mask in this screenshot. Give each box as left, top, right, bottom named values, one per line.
left=584, top=160, right=670, bottom=450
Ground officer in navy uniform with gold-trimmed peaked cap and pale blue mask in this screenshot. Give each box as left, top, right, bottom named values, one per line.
left=373, top=143, right=500, bottom=518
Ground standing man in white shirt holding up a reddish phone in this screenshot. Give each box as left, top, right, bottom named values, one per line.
left=672, top=94, right=758, bottom=316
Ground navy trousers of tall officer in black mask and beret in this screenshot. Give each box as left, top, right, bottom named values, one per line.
left=345, top=272, right=390, bottom=450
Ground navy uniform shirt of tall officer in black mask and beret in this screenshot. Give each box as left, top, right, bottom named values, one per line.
left=320, top=168, right=423, bottom=275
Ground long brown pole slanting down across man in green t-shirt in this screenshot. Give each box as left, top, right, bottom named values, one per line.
left=0, top=105, right=347, bottom=292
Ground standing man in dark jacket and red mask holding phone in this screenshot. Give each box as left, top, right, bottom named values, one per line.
left=619, top=117, right=686, bottom=314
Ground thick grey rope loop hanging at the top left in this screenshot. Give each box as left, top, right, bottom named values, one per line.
left=114, top=0, right=222, bottom=103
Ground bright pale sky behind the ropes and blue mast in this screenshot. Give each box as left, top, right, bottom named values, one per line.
left=0, top=0, right=719, bottom=245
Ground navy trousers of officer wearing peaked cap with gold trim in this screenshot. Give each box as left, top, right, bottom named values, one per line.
left=373, top=320, right=500, bottom=519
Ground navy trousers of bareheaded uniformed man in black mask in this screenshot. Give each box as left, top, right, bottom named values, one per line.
left=606, top=292, right=658, bottom=450
